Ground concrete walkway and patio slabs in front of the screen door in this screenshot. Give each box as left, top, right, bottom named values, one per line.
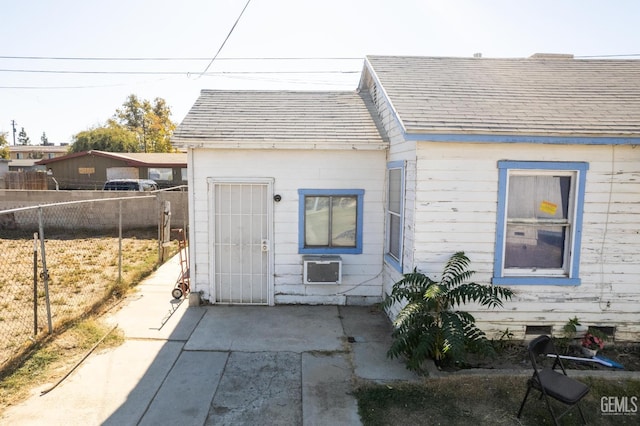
left=0, top=255, right=421, bottom=426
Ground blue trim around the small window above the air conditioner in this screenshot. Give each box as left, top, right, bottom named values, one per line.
left=298, top=189, right=364, bottom=254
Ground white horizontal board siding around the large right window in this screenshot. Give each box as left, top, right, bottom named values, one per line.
left=410, top=142, right=640, bottom=341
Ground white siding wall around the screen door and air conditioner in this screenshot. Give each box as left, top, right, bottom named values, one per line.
left=190, top=149, right=386, bottom=304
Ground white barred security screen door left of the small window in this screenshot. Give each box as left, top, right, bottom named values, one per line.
left=212, top=181, right=272, bottom=305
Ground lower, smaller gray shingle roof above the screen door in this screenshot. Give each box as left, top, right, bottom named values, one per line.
left=172, top=90, right=387, bottom=149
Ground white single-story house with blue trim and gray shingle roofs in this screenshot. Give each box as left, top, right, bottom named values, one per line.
left=173, top=54, right=640, bottom=341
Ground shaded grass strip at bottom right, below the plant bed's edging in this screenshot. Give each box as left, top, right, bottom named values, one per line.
left=356, top=375, right=640, bottom=426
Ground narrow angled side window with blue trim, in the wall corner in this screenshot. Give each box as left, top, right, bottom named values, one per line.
left=385, top=161, right=404, bottom=272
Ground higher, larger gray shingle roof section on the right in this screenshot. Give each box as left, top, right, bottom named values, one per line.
left=361, top=55, right=640, bottom=137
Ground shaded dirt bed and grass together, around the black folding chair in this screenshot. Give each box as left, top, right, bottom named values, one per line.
left=356, top=341, right=640, bottom=426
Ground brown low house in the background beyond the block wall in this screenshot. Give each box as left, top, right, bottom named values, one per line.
left=36, top=150, right=187, bottom=189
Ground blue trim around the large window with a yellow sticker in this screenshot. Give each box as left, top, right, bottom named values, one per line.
left=492, top=160, right=589, bottom=286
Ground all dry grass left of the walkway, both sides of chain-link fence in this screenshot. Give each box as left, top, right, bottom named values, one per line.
left=0, top=233, right=172, bottom=412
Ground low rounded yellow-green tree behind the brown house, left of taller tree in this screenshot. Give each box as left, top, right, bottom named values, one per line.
left=70, top=126, right=139, bottom=152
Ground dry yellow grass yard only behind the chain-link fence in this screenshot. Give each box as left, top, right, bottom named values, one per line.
left=0, top=235, right=165, bottom=367
